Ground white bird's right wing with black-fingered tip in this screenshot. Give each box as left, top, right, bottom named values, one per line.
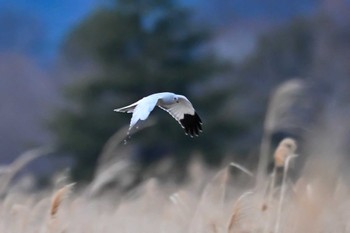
left=158, top=95, right=202, bottom=136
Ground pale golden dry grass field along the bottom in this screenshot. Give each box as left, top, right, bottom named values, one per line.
left=0, top=146, right=350, bottom=233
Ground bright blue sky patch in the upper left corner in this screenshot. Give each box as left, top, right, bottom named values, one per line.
left=0, top=0, right=101, bottom=63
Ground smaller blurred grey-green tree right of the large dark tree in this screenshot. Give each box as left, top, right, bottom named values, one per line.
left=227, top=18, right=315, bottom=157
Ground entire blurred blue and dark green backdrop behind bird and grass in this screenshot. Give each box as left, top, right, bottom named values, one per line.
left=0, top=0, right=350, bottom=186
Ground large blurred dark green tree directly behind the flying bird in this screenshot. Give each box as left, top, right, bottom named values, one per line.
left=52, top=0, right=242, bottom=180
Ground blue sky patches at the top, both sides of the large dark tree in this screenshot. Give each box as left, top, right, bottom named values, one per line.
left=0, top=0, right=315, bottom=63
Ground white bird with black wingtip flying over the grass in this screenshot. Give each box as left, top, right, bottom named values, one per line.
left=114, top=92, right=202, bottom=137
